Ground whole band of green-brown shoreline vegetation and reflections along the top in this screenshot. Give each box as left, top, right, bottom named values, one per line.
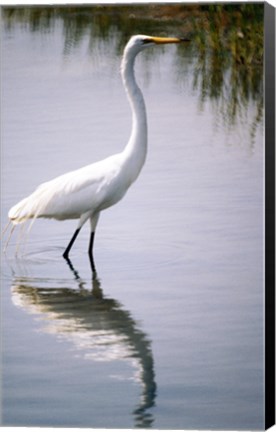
left=2, top=3, right=264, bottom=141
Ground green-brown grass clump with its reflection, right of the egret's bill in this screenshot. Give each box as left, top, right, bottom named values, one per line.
left=190, top=3, right=263, bottom=137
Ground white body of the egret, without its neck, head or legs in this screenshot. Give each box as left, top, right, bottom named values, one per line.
left=9, top=153, right=135, bottom=227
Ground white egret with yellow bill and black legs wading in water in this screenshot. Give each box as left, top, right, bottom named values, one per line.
left=5, top=35, right=185, bottom=270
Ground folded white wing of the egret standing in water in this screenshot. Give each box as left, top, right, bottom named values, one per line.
left=9, top=155, right=119, bottom=223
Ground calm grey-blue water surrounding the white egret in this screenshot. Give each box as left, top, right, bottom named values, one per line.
left=2, top=8, right=264, bottom=429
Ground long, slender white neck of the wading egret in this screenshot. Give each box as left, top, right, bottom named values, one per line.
left=121, top=51, right=147, bottom=181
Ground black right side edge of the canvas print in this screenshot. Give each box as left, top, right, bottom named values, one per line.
left=264, top=2, right=275, bottom=429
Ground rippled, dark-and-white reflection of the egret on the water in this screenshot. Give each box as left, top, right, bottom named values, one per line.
left=9, top=267, right=156, bottom=427
